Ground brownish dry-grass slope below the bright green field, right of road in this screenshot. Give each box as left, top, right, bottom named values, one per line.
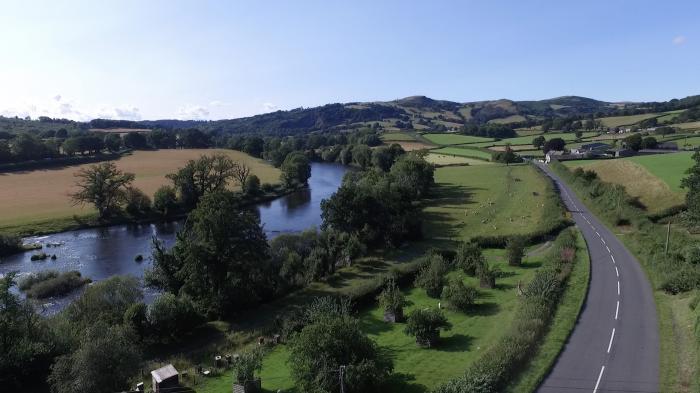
left=564, top=153, right=684, bottom=213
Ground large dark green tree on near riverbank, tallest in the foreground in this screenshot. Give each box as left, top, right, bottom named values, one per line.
left=147, top=191, right=269, bottom=316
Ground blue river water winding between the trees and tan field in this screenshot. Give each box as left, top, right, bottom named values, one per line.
left=0, top=163, right=347, bottom=314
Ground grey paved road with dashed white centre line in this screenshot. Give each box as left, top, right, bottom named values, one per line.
left=538, top=164, right=659, bottom=393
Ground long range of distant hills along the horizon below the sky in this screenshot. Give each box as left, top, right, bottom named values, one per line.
left=0, top=95, right=700, bottom=135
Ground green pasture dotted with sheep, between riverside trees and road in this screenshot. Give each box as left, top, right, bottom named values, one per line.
left=425, top=164, right=547, bottom=240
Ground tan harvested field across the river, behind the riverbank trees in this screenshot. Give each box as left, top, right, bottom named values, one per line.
left=0, top=149, right=280, bottom=232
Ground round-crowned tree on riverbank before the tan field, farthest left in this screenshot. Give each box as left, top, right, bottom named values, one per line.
left=71, top=162, right=134, bottom=218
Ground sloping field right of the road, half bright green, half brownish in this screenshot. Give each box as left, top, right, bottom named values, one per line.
left=564, top=152, right=691, bottom=213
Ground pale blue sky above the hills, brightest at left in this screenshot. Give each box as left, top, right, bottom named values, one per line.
left=0, top=0, right=700, bottom=120
